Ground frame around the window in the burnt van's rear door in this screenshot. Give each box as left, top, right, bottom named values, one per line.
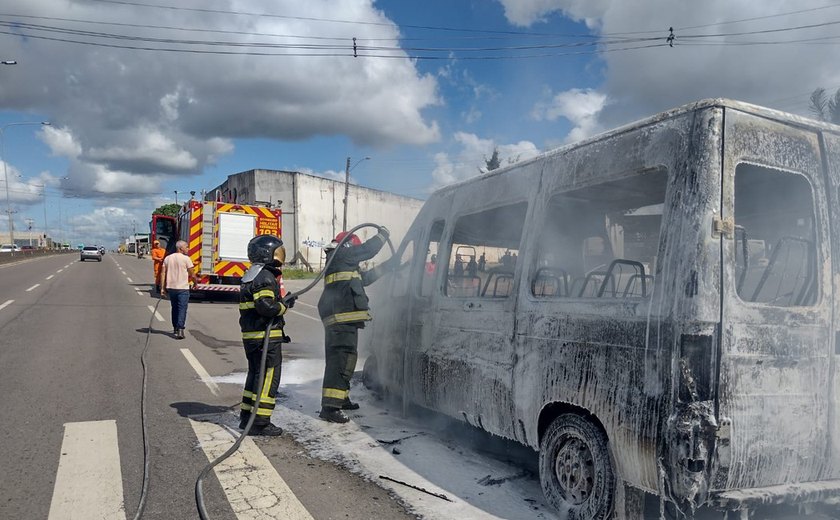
left=723, top=159, right=826, bottom=312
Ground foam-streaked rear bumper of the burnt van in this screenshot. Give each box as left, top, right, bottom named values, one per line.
left=709, top=480, right=840, bottom=509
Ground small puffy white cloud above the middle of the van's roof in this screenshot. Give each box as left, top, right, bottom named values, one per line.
left=531, top=88, right=607, bottom=143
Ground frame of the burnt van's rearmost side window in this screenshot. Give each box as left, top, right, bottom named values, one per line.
left=520, top=164, right=673, bottom=306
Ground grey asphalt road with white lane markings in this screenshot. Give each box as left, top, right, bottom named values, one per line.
left=0, top=254, right=412, bottom=519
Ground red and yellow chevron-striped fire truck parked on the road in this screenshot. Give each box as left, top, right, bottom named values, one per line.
left=150, top=199, right=282, bottom=292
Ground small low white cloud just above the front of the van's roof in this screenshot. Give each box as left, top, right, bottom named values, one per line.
left=432, top=132, right=540, bottom=189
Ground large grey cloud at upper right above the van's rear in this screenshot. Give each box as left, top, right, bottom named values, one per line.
left=499, top=0, right=840, bottom=132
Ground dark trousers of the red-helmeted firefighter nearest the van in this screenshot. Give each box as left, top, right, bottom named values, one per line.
left=321, top=325, right=359, bottom=408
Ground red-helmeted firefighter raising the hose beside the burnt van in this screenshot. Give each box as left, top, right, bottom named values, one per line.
left=318, top=227, right=390, bottom=423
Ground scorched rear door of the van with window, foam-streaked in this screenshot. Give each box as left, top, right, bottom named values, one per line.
left=715, top=109, right=836, bottom=490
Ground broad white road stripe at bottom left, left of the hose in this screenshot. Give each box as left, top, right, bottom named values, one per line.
left=48, top=421, right=125, bottom=520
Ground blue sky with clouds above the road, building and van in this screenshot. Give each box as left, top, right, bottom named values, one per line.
left=0, top=0, right=840, bottom=247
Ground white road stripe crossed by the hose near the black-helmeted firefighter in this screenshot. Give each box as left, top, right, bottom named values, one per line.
left=190, top=419, right=312, bottom=520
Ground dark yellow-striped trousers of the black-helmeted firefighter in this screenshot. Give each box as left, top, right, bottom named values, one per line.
left=239, top=341, right=283, bottom=427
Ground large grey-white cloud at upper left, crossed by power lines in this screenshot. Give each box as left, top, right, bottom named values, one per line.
left=0, top=0, right=441, bottom=197
